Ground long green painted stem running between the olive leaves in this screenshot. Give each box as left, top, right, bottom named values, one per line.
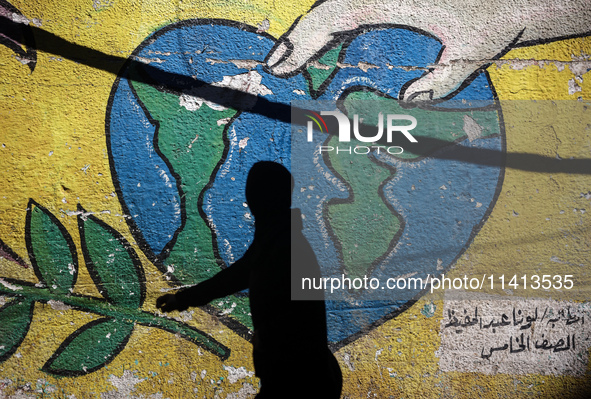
left=0, top=281, right=230, bottom=359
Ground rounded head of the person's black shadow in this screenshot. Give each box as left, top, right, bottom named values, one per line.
left=246, top=161, right=294, bottom=218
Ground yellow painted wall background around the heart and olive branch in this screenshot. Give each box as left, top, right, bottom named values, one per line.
left=0, top=0, right=591, bottom=399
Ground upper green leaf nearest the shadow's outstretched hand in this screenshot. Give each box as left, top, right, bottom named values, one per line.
left=78, top=208, right=145, bottom=308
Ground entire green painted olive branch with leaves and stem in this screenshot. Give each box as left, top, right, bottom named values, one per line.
left=0, top=200, right=230, bottom=376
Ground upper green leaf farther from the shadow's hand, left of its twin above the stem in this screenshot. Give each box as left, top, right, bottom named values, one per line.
left=25, top=200, right=78, bottom=294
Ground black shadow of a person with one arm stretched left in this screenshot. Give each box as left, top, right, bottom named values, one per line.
left=156, top=161, right=342, bottom=399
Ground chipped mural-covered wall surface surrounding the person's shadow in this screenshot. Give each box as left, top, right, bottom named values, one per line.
left=0, top=0, right=591, bottom=399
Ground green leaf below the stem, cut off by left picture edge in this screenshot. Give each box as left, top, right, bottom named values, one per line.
left=0, top=297, right=33, bottom=362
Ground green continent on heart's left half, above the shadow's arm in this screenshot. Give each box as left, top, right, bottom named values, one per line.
left=133, top=82, right=252, bottom=328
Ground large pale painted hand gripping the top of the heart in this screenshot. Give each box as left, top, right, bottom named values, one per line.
left=267, top=0, right=591, bottom=102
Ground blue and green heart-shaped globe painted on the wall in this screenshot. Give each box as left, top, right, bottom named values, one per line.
left=106, top=20, right=504, bottom=347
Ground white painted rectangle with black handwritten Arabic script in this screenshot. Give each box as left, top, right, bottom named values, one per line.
left=438, top=299, right=591, bottom=375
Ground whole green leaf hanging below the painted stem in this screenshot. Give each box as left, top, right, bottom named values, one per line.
left=43, top=318, right=134, bottom=376
